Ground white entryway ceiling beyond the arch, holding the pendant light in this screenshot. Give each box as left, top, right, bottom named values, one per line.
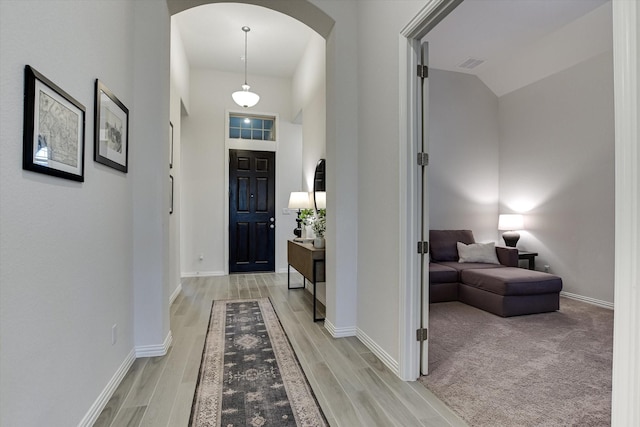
left=174, top=3, right=315, bottom=77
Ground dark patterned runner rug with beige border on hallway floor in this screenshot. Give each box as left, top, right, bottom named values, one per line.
left=189, top=298, right=328, bottom=427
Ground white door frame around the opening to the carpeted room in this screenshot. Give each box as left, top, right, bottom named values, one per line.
left=399, top=0, right=640, bottom=426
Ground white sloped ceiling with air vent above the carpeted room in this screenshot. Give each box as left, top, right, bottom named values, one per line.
left=423, top=0, right=613, bottom=96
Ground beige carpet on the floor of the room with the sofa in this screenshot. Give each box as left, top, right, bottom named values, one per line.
left=420, top=298, right=613, bottom=427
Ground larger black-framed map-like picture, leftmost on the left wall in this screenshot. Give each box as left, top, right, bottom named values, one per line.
left=22, top=65, right=86, bottom=182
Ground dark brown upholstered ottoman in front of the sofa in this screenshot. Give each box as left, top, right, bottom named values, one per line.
left=458, top=267, right=562, bottom=317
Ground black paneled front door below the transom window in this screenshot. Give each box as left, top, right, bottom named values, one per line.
left=229, top=150, right=276, bottom=273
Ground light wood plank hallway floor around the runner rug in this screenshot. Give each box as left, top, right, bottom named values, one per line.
left=94, top=273, right=466, bottom=427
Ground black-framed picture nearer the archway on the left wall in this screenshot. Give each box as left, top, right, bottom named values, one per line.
left=93, top=79, right=129, bottom=173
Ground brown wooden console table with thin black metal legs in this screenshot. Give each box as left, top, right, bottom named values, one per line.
left=287, top=240, right=324, bottom=322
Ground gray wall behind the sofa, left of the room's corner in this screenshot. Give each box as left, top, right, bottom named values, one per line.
left=427, top=69, right=504, bottom=245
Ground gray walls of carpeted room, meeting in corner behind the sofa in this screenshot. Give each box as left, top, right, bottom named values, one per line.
left=429, top=52, right=615, bottom=306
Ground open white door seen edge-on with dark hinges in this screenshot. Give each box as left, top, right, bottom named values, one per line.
left=418, top=42, right=429, bottom=375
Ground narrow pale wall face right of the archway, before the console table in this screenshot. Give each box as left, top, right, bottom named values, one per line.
left=311, top=0, right=358, bottom=336
